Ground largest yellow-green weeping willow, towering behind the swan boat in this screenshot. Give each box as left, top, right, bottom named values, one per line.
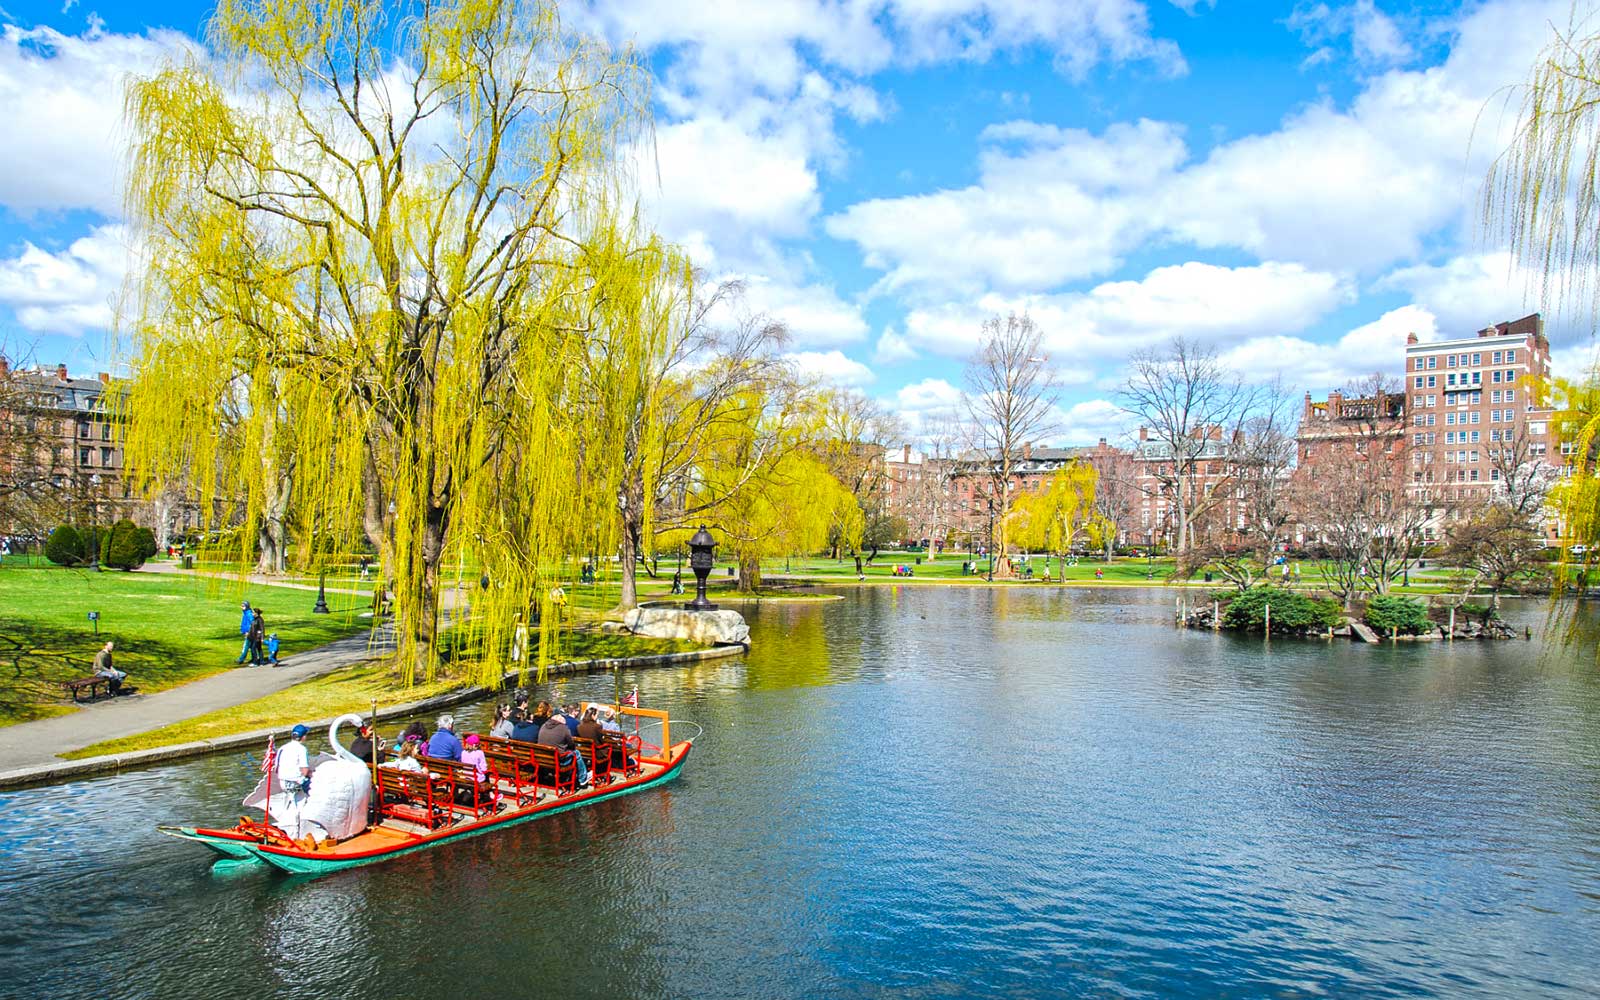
left=116, top=0, right=648, bottom=680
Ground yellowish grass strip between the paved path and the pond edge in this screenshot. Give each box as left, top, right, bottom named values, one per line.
left=62, top=632, right=699, bottom=760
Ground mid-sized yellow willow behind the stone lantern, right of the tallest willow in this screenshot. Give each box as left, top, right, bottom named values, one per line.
left=578, top=222, right=803, bottom=610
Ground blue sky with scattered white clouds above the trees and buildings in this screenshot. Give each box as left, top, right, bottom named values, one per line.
left=0, top=0, right=1589, bottom=443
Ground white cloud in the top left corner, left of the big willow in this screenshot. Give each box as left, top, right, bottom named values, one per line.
left=0, top=24, right=194, bottom=218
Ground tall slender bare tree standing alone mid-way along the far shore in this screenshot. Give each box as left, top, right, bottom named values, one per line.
left=965, top=312, right=1056, bottom=573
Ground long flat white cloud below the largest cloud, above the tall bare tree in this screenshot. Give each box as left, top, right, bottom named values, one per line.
left=906, top=261, right=1354, bottom=358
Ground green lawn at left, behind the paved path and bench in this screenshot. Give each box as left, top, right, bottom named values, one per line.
left=0, top=560, right=366, bottom=725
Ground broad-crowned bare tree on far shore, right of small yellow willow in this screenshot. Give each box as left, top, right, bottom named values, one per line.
left=1118, top=338, right=1258, bottom=554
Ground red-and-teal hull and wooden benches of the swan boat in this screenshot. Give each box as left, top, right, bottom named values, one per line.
left=157, top=704, right=693, bottom=875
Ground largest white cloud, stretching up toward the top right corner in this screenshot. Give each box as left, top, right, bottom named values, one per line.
left=826, top=0, right=1563, bottom=298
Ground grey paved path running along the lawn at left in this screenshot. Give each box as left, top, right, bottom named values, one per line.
left=0, top=627, right=394, bottom=771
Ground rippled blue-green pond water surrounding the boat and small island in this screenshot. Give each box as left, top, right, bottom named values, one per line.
left=0, top=587, right=1600, bottom=1000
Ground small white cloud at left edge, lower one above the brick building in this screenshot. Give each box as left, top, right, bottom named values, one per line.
left=0, top=226, right=128, bottom=336
